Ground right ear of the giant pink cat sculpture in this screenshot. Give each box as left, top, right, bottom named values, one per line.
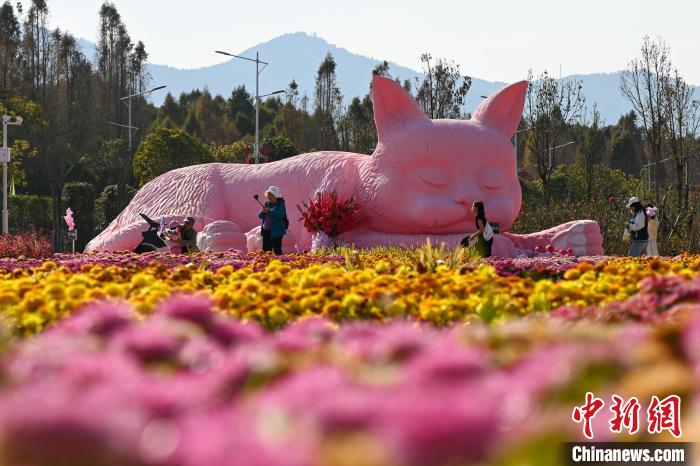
left=472, top=81, right=527, bottom=139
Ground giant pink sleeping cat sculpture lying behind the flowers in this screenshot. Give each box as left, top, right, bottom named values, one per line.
left=86, top=77, right=603, bottom=257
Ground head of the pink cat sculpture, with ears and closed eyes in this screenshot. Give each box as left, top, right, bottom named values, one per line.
left=360, top=76, right=527, bottom=234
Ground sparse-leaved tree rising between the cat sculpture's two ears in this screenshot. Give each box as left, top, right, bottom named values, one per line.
left=416, top=53, right=472, bottom=119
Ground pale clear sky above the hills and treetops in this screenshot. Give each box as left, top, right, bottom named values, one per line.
left=43, top=0, right=700, bottom=84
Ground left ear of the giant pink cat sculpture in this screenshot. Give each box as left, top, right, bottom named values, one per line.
left=372, top=76, right=429, bottom=141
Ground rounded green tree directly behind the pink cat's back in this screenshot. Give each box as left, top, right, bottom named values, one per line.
left=133, top=128, right=213, bottom=186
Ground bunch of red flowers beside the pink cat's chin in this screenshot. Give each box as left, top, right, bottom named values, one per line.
left=297, top=191, right=360, bottom=236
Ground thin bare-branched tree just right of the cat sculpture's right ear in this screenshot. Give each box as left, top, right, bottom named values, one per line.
left=523, top=70, right=586, bottom=205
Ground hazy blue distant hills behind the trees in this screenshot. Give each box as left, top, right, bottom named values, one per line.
left=79, top=32, right=700, bottom=124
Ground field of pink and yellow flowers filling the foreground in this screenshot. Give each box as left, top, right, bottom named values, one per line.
left=0, top=248, right=700, bottom=466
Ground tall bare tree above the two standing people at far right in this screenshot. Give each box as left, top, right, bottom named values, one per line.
left=620, top=36, right=671, bottom=202
